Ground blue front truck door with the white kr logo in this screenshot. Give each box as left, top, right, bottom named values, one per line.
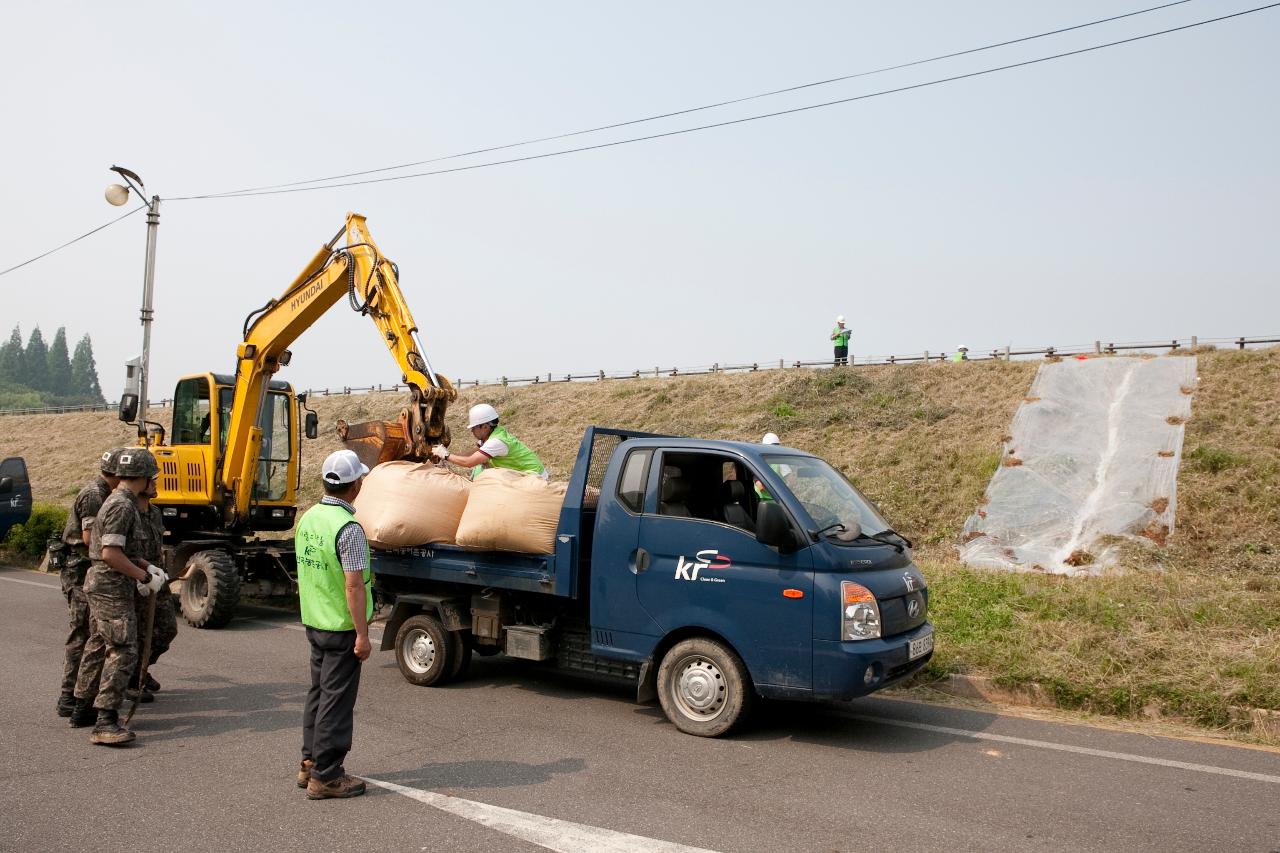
left=635, top=451, right=813, bottom=689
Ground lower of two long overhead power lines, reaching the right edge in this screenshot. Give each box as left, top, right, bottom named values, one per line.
left=172, top=3, right=1280, bottom=201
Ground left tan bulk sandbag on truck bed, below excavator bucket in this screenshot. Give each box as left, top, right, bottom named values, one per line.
left=355, top=461, right=471, bottom=548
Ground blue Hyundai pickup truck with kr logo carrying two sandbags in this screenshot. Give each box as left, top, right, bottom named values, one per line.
left=372, top=427, right=933, bottom=736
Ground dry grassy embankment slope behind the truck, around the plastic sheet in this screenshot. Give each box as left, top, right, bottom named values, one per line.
left=0, top=348, right=1280, bottom=729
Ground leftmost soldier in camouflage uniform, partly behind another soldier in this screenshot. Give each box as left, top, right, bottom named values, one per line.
left=50, top=447, right=123, bottom=717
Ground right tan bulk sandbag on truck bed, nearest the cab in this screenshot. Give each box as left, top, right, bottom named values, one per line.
left=457, top=467, right=567, bottom=553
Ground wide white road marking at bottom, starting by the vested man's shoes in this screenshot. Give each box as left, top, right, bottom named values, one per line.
left=361, top=776, right=714, bottom=853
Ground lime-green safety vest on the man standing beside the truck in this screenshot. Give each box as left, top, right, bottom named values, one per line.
left=293, top=503, right=374, bottom=631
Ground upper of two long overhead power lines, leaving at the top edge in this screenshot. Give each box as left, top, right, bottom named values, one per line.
left=192, top=0, right=1192, bottom=199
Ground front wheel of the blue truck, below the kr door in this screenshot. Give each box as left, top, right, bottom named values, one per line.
left=658, top=637, right=754, bottom=738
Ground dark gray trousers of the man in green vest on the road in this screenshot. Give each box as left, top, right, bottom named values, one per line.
left=302, top=625, right=360, bottom=781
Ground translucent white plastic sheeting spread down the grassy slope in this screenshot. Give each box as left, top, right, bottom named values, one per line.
left=960, top=356, right=1196, bottom=575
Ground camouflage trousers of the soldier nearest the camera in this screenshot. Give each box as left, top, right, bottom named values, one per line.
left=76, top=564, right=138, bottom=711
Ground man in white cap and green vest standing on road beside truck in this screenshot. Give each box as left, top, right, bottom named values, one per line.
left=294, top=450, right=374, bottom=799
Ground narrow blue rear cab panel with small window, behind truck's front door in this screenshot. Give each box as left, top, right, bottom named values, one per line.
left=591, top=443, right=662, bottom=645
